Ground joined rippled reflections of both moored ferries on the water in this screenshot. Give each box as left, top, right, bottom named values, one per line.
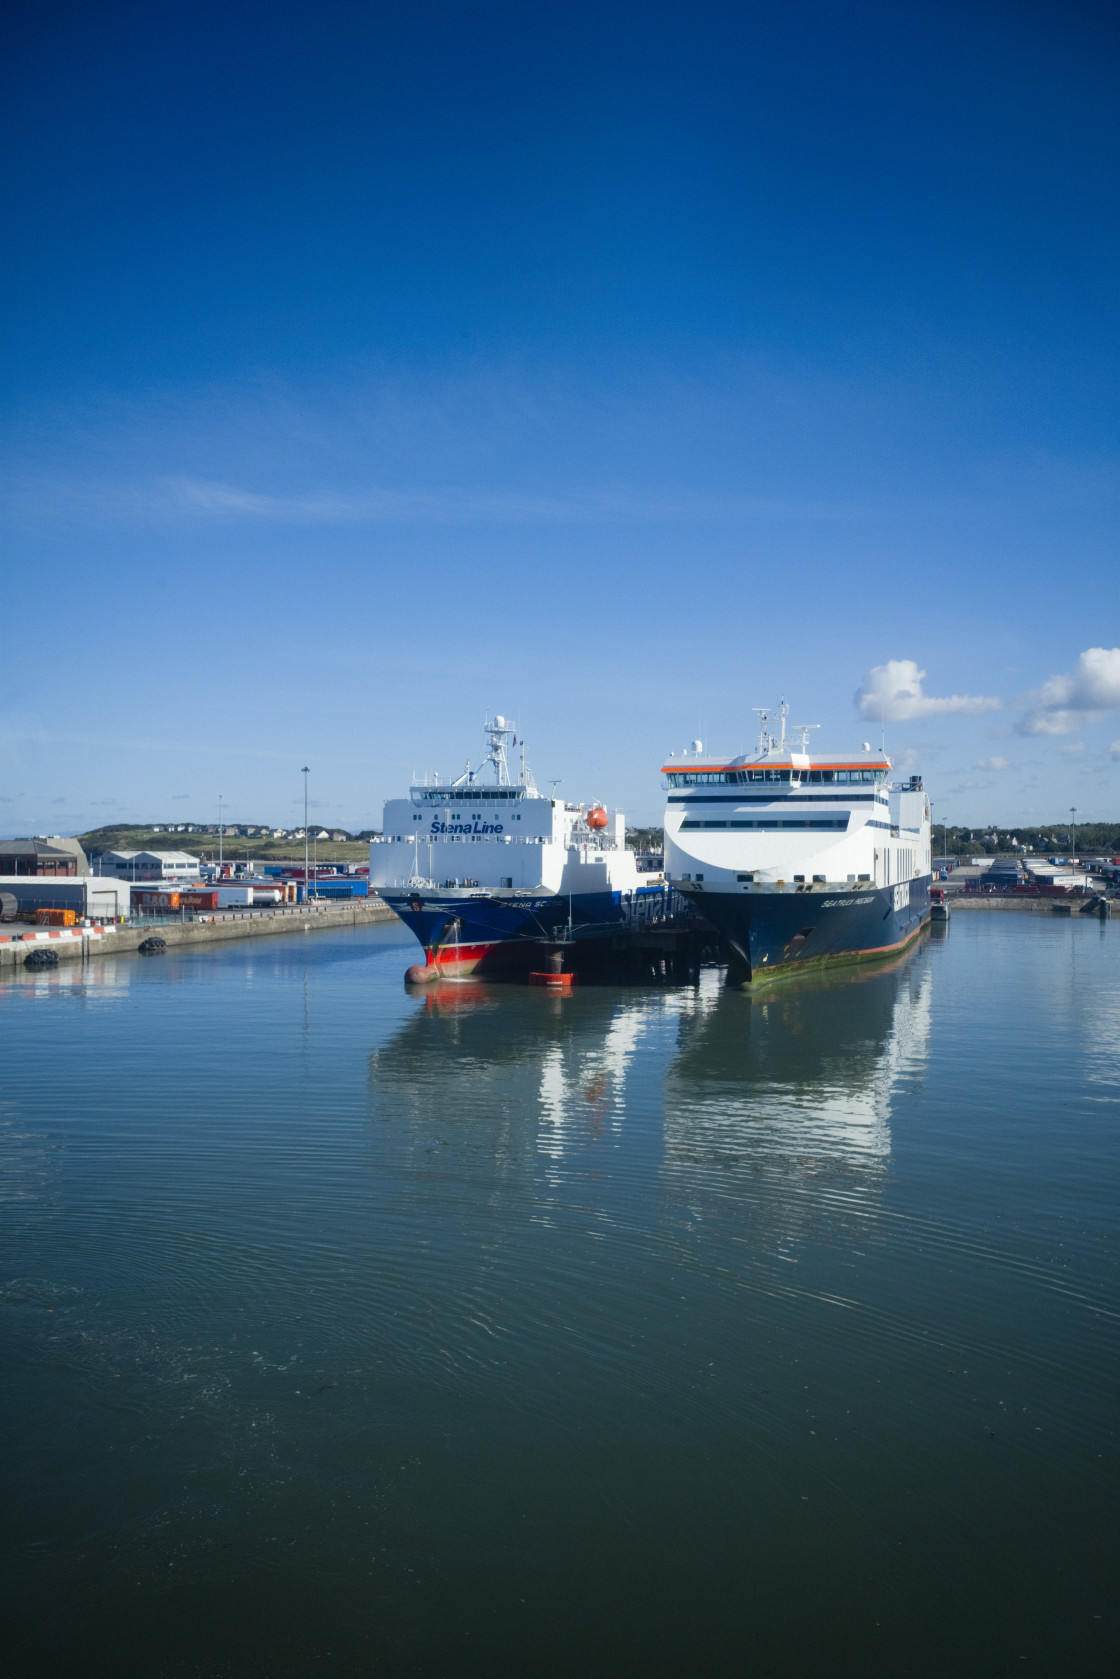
left=369, top=950, right=932, bottom=1235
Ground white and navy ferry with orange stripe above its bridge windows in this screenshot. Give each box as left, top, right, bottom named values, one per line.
left=662, top=700, right=932, bottom=981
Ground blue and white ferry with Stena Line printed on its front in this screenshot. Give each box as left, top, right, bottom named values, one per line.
left=369, top=715, right=672, bottom=982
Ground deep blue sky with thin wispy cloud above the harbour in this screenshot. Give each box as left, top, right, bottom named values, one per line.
left=0, top=0, right=1120, bottom=833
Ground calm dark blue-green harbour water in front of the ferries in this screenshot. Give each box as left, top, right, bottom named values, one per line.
left=0, top=913, right=1120, bottom=1679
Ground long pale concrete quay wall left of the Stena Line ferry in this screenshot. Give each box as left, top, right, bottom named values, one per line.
left=0, top=898, right=396, bottom=974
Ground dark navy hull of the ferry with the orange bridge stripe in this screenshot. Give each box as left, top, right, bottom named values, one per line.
left=682, top=875, right=932, bottom=979
